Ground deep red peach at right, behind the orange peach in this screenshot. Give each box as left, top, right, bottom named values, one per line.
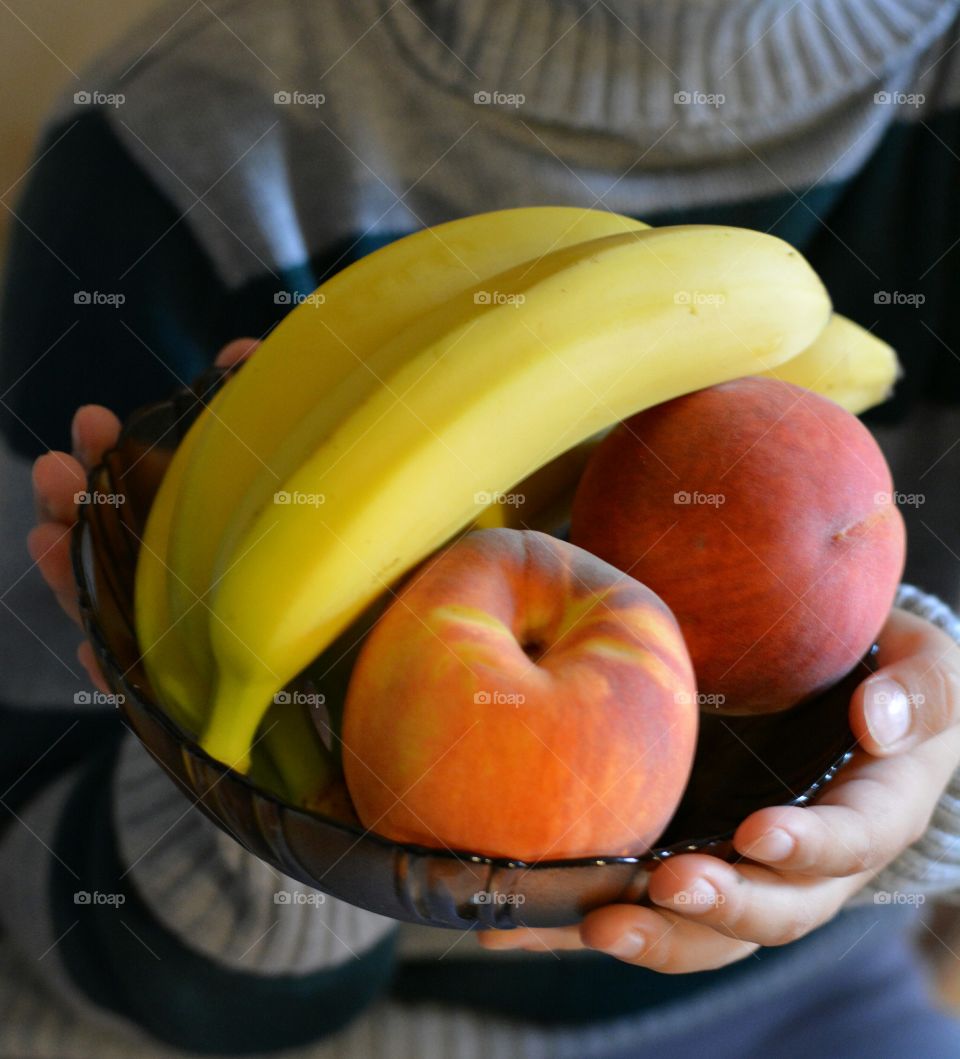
left=570, top=378, right=906, bottom=713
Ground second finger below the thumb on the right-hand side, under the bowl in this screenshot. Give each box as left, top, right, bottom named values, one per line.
left=649, top=854, right=867, bottom=946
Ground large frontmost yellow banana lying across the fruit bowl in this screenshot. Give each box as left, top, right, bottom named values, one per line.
left=201, top=226, right=830, bottom=769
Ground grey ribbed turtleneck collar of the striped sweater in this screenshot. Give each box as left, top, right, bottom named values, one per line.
left=382, top=0, right=957, bottom=144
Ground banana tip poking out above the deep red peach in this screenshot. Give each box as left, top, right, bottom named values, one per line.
left=760, top=312, right=900, bottom=415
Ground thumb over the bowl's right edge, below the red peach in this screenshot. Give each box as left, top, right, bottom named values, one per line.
left=850, top=610, right=960, bottom=756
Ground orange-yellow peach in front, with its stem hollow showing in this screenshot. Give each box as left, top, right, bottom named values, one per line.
left=343, top=528, right=698, bottom=861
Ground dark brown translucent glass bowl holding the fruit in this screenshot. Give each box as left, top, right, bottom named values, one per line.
left=73, top=370, right=876, bottom=930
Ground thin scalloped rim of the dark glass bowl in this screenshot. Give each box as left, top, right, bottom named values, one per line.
left=70, top=385, right=855, bottom=872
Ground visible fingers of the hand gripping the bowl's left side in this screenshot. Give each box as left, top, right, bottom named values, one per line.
left=26, top=338, right=259, bottom=692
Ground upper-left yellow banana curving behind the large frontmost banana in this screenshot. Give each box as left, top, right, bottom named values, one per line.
left=153, top=207, right=648, bottom=694
